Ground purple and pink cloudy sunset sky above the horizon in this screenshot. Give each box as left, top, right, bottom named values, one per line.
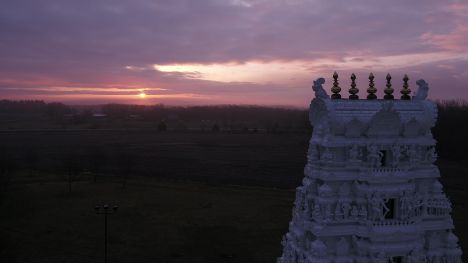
left=0, top=0, right=468, bottom=107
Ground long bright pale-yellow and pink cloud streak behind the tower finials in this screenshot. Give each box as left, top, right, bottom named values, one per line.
left=152, top=52, right=468, bottom=84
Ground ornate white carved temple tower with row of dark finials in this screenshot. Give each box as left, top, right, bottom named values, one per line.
left=277, top=73, right=462, bottom=263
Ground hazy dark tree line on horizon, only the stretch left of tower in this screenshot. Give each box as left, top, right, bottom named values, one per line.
left=0, top=100, right=310, bottom=132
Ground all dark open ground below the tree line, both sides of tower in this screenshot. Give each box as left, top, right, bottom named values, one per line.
left=0, top=131, right=468, bottom=262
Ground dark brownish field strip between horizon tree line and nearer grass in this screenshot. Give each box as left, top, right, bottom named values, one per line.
left=0, top=130, right=310, bottom=188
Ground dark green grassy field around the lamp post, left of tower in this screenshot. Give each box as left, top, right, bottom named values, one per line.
left=0, top=174, right=294, bottom=262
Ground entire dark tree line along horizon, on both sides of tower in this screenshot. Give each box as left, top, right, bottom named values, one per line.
left=0, top=100, right=468, bottom=160
